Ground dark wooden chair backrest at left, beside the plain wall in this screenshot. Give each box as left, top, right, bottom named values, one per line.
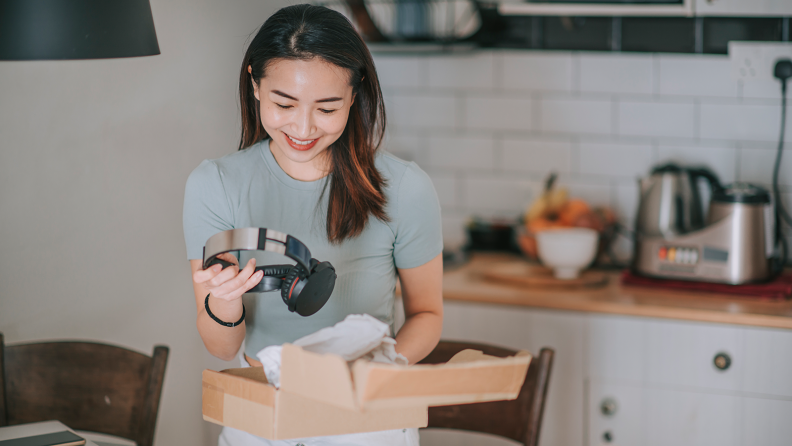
left=0, top=333, right=168, bottom=446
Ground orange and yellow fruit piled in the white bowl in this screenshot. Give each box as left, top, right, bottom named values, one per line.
left=517, top=174, right=616, bottom=259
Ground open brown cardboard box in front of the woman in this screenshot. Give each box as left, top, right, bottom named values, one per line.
left=203, top=344, right=531, bottom=440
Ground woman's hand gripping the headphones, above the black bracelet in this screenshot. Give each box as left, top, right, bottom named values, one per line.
left=193, top=253, right=264, bottom=302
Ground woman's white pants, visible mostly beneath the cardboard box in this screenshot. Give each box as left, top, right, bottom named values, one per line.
left=217, top=352, right=420, bottom=446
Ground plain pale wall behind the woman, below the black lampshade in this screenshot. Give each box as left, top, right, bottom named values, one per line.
left=0, top=0, right=291, bottom=445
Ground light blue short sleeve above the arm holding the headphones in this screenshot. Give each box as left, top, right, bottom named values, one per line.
left=182, top=160, right=234, bottom=260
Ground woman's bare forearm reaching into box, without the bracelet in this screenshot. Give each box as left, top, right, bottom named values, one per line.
left=396, top=254, right=443, bottom=364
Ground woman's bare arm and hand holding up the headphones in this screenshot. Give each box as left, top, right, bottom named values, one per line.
left=190, top=254, right=263, bottom=361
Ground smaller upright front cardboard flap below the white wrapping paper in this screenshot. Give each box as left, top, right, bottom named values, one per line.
left=280, top=344, right=358, bottom=410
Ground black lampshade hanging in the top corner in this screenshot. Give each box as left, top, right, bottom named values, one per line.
left=0, top=0, right=160, bottom=60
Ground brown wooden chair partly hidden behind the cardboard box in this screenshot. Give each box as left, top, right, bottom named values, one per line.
left=421, top=341, right=555, bottom=446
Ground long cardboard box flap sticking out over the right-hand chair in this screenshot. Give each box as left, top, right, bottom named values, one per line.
left=352, top=350, right=531, bottom=410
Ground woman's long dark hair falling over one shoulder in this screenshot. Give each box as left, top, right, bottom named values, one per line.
left=239, top=5, right=388, bottom=243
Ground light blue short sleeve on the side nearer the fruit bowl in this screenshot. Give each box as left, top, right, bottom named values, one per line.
left=392, top=163, right=443, bottom=269
